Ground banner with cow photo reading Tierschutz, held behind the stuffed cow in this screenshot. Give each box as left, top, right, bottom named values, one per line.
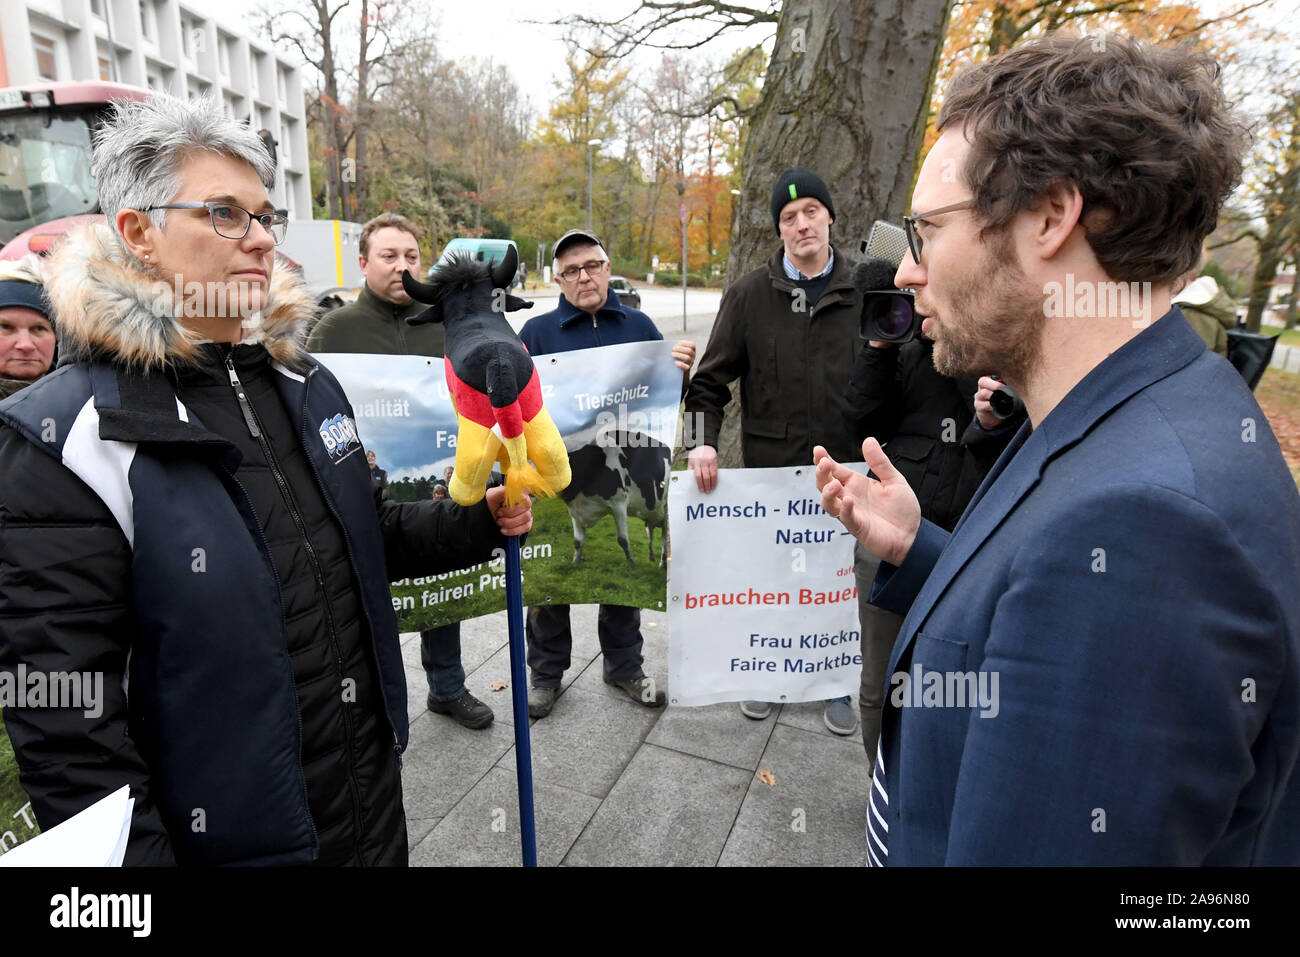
left=316, top=342, right=681, bottom=632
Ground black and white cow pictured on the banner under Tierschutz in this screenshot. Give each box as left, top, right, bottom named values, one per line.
left=560, top=432, right=672, bottom=568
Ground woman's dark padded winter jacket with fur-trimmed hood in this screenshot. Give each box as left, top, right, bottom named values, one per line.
left=0, top=228, right=503, bottom=863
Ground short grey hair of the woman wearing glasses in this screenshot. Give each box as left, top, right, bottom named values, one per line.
left=91, top=94, right=276, bottom=234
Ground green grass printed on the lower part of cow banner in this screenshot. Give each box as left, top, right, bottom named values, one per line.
left=393, top=488, right=666, bottom=632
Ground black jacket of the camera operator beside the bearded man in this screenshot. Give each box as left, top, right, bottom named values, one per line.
left=844, top=338, right=1024, bottom=532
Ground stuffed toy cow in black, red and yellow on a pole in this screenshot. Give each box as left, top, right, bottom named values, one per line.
left=402, top=247, right=569, bottom=506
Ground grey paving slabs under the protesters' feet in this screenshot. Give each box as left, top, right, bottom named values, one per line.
left=402, top=605, right=868, bottom=866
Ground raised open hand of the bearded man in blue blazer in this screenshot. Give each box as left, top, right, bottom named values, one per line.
left=813, top=438, right=920, bottom=566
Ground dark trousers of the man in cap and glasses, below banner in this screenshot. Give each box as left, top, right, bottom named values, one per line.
left=524, top=605, right=642, bottom=688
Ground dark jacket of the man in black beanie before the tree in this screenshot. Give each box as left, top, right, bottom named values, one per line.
left=686, top=250, right=862, bottom=468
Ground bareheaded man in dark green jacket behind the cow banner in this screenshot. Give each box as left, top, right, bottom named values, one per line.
left=307, top=213, right=494, bottom=728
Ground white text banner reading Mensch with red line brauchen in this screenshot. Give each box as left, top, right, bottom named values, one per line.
left=668, top=463, right=866, bottom=705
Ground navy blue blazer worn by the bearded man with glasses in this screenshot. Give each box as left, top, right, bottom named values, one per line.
left=871, top=308, right=1300, bottom=865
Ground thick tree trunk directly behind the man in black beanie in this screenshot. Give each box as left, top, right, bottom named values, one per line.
left=718, top=0, right=949, bottom=467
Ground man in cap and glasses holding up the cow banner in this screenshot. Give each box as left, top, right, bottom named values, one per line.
left=519, top=229, right=696, bottom=718
